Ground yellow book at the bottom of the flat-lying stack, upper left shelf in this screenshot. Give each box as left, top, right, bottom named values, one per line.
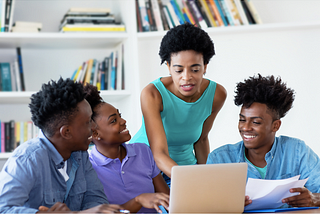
left=60, top=24, right=126, bottom=32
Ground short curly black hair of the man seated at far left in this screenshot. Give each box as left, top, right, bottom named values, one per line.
left=29, top=77, right=85, bottom=137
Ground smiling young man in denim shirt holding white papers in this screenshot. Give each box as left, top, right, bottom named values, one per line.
left=207, top=74, right=320, bottom=207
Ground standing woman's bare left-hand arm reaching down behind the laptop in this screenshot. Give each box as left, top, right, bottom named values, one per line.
left=141, top=84, right=178, bottom=177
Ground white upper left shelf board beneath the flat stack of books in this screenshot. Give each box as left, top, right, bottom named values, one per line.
left=0, top=32, right=128, bottom=49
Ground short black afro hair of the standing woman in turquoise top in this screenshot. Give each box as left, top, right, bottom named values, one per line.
left=159, top=22, right=215, bottom=65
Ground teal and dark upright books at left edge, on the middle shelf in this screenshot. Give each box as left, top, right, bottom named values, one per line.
left=0, top=47, right=25, bottom=91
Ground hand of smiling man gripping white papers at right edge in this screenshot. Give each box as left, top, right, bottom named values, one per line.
left=282, top=188, right=320, bottom=207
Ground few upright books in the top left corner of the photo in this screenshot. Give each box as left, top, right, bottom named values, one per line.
left=0, top=0, right=16, bottom=32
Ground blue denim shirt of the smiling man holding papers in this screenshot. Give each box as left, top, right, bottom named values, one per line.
left=207, top=136, right=320, bottom=193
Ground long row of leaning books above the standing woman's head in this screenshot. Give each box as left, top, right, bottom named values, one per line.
left=135, top=0, right=262, bottom=32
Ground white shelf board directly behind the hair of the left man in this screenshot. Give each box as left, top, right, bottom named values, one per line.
left=0, top=90, right=131, bottom=104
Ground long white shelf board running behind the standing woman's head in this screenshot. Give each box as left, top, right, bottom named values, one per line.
left=138, top=21, right=320, bottom=40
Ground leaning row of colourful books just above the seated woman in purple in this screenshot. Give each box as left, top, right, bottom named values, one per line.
left=71, top=44, right=125, bottom=90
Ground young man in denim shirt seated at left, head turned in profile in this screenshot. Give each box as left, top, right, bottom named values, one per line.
left=0, top=78, right=120, bottom=213
